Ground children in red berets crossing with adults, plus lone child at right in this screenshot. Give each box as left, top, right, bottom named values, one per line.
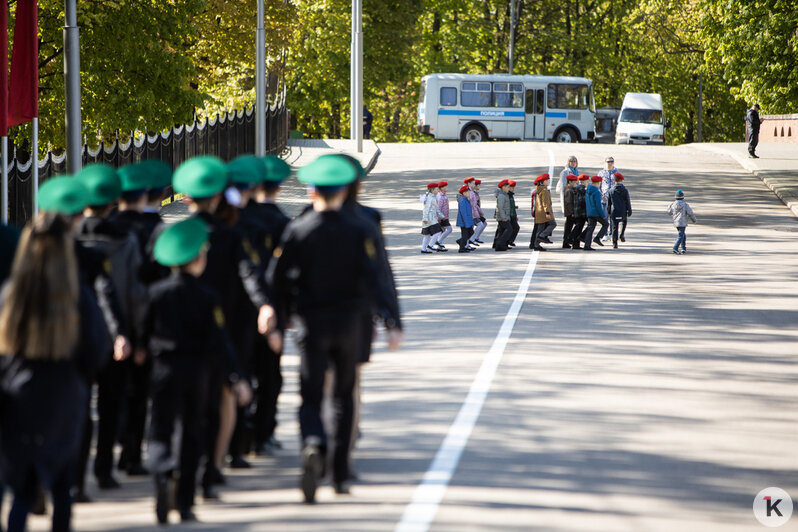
left=420, top=156, right=695, bottom=254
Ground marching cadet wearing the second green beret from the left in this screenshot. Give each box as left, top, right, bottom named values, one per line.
left=75, top=164, right=147, bottom=489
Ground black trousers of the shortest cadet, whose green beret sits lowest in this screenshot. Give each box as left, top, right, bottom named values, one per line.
left=148, top=355, right=209, bottom=510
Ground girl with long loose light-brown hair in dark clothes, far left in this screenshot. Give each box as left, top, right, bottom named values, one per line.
left=0, top=213, right=108, bottom=532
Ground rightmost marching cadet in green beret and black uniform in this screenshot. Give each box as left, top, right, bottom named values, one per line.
left=268, top=156, right=400, bottom=503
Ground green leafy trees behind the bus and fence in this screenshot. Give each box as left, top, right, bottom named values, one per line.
left=9, top=0, right=798, bottom=154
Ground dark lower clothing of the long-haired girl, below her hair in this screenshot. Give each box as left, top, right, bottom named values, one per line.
left=0, top=285, right=110, bottom=489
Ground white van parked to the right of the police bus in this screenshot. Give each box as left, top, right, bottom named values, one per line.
left=615, top=92, right=670, bottom=144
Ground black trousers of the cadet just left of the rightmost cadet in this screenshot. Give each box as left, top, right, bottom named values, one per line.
left=252, top=335, right=283, bottom=448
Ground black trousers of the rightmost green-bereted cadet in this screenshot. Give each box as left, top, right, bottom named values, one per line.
left=298, top=310, right=364, bottom=482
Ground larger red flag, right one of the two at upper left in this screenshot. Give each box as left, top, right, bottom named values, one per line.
left=8, top=0, right=39, bottom=127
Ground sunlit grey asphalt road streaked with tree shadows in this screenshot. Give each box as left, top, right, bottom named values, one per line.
left=23, top=142, right=798, bottom=532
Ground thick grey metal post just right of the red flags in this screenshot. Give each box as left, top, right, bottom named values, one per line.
left=64, top=0, right=83, bottom=175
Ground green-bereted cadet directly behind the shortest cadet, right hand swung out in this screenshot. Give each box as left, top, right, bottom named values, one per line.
left=173, top=155, right=264, bottom=499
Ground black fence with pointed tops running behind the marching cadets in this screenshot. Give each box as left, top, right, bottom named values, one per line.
left=8, top=97, right=288, bottom=227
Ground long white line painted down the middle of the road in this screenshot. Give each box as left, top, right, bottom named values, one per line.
left=395, top=249, right=540, bottom=532
